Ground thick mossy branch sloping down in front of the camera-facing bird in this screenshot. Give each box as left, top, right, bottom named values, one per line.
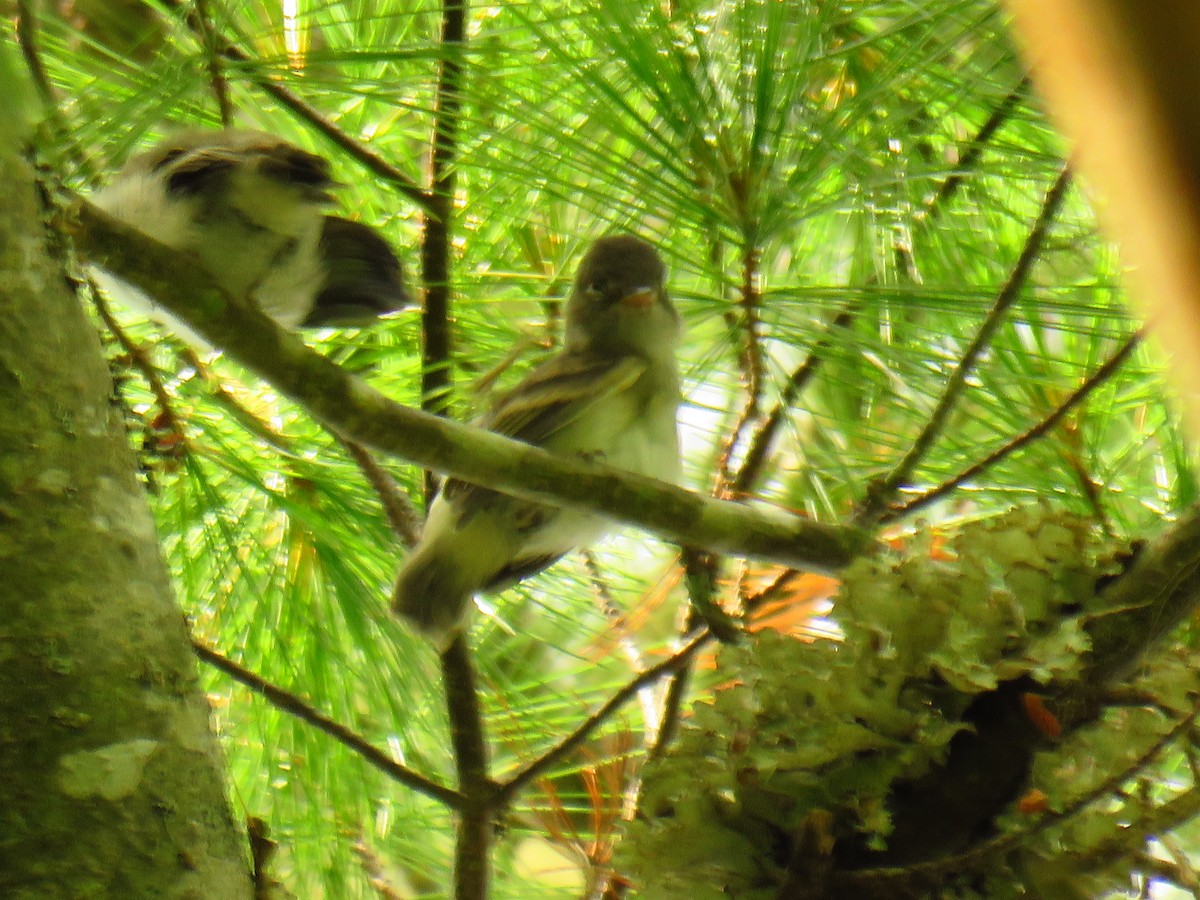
left=60, top=199, right=874, bottom=572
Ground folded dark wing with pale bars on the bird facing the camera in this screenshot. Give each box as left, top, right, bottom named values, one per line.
left=444, top=354, right=647, bottom=509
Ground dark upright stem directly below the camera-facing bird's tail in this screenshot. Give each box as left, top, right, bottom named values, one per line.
left=442, top=635, right=500, bottom=900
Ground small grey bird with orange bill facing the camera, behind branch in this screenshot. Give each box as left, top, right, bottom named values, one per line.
left=392, top=235, right=680, bottom=649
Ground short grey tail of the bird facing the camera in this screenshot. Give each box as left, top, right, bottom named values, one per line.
left=391, top=542, right=478, bottom=650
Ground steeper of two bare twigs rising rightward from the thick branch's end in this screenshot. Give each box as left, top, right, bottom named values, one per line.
left=854, top=166, right=1070, bottom=527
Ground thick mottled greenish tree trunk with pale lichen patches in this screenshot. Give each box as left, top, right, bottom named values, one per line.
left=0, top=144, right=253, bottom=900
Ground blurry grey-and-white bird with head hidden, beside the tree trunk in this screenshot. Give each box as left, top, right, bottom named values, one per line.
left=92, top=128, right=408, bottom=331
